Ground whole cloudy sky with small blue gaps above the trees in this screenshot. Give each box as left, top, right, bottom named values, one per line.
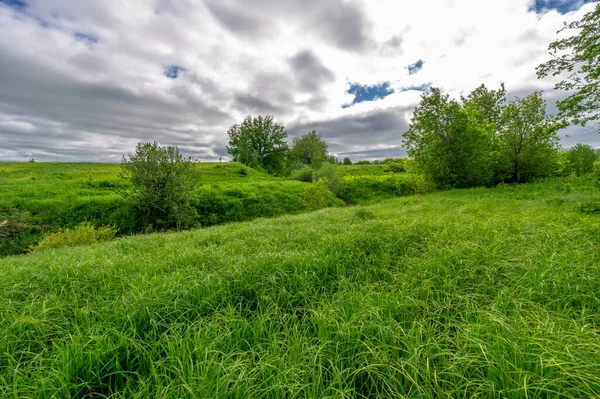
left=0, top=0, right=600, bottom=162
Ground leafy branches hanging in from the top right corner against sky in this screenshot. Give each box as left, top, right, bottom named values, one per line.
left=537, top=0, right=600, bottom=126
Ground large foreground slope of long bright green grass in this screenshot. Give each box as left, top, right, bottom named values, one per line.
left=0, top=179, right=600, bottom=398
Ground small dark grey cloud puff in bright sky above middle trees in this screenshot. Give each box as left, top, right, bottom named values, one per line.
left=290, top=50, right=335, bottom=92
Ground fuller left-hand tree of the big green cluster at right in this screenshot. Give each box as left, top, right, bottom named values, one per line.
left=403, top=87, right=491, bottom=187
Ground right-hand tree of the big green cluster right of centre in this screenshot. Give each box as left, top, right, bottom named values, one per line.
left=498, top=92, right=560, bottom=183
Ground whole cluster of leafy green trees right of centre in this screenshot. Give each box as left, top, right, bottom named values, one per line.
left=403, top=85, right=561, bottom=187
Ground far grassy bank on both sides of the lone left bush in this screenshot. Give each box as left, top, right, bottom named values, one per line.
left=0, top=163, right=305, bottom=256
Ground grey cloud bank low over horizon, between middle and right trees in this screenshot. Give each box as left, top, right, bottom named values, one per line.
left=288, top=107, right=413, bottom=158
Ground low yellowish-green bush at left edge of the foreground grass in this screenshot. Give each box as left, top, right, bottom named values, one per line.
left=29, top=222, right=117, bottom=252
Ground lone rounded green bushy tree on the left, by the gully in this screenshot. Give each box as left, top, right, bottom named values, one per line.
left=121, top=142, right=200, bottom=230
